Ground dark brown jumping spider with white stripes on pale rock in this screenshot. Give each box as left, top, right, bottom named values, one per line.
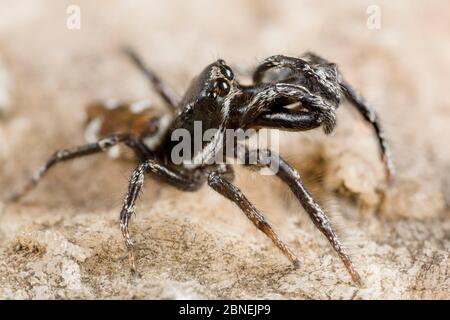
left=8, top=49, right=394, bottom=282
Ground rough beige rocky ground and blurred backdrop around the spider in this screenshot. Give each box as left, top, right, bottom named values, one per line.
left=0, top=0, right=450, bottom=299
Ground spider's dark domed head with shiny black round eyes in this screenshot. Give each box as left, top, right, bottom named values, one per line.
left=178, top=59, right=237, bottom=129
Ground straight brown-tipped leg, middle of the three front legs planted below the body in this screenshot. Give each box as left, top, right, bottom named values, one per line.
left=208, top=171, right=300, bottom=267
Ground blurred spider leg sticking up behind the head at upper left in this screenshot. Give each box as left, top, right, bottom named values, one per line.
left=123, top=48, right=181, bottom=111
